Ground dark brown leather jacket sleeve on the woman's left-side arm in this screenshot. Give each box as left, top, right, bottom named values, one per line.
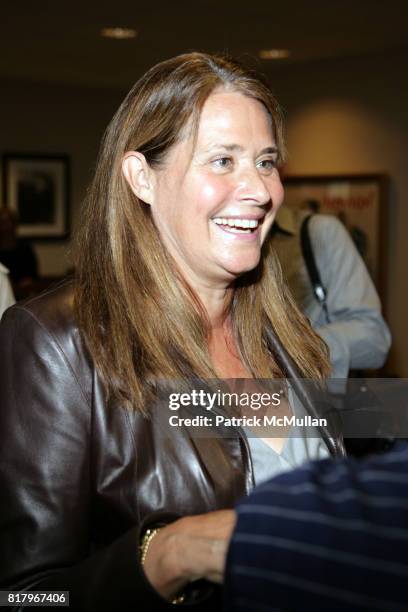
left=0, top=305, right=215, bottom=612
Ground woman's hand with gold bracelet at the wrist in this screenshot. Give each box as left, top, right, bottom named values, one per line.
left=144, top=510, right=236, bottom=599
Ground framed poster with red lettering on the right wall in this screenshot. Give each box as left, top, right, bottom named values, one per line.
left=283, top=174, right=388, bottom=299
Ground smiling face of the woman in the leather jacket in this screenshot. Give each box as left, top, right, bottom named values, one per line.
left=151, top=91, right=283, bottom=287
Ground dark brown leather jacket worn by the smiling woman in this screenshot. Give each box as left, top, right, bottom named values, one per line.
left=0, top=283, right=344, bottom=612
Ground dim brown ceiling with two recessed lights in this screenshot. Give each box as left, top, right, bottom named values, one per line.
left=0, top=0, right=408, bottom=88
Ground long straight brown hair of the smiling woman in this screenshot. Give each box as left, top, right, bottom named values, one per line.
left=75, top=53, right=329, bottom=411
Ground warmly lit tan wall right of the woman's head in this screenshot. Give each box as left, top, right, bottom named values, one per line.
left=270, top=52, right=408, bottom=377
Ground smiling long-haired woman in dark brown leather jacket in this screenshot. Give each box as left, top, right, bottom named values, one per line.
left=0, top=53, right=341, bottom=611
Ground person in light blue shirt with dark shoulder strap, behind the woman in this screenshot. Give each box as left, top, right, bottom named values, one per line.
left=271, top=206, right=391, bottom=379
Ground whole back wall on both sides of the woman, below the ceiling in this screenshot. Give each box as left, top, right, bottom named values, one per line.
left=0, top=52, right=408, bottom=377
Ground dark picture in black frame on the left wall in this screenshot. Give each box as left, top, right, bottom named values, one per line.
left=3, top=153, right=69, bottom=240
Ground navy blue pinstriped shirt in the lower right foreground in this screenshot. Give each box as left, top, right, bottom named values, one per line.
left=225, top=442, right=408, bottom=612
